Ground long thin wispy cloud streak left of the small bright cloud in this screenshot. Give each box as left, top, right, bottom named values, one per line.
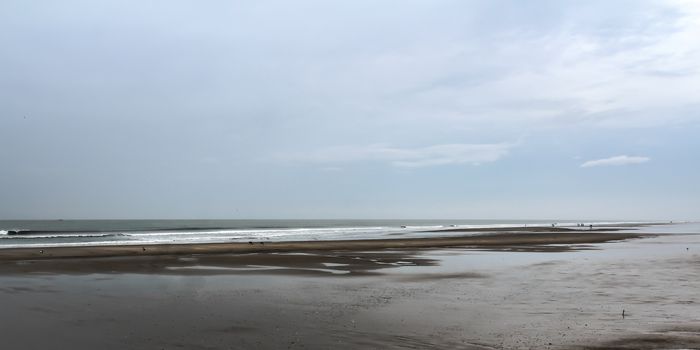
left=282, top=143, right=511, bottom=168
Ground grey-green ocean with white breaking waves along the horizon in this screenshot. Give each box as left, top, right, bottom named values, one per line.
left=0, top=220, right=664, bottom=249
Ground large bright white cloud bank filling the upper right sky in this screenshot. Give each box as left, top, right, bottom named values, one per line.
left=294, top=1, right=700, bottom=130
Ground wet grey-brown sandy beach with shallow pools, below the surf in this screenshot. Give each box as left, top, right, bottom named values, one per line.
left=0, top=225, right=700, bottom=349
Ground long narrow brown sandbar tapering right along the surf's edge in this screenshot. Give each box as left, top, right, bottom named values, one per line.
left=0, top=229, right=644, bottom=261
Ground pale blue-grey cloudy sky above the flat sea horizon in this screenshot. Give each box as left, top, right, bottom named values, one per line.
left=0, top=0, right=700, bottom=220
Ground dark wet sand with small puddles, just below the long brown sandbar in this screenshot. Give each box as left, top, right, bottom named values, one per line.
left=0, top=250, right=437, bottom=278
